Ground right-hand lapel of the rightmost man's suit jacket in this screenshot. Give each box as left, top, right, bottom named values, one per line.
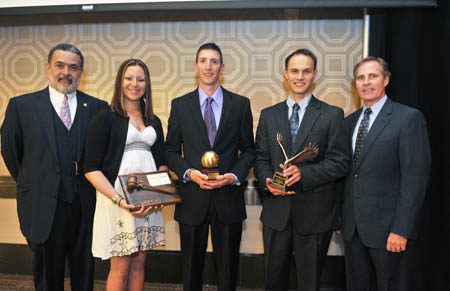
left=355, top=99, right=392, bottom=170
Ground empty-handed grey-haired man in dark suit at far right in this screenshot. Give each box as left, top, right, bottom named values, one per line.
left=342, top=57, right=431, bottom=291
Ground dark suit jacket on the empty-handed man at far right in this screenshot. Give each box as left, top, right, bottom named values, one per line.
left=342, top=99, right=431, bottom=248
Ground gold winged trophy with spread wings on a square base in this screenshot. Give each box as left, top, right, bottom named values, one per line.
left=270, top=132, right=319, bottom=192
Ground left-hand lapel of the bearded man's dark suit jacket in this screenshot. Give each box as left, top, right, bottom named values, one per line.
left=36, top=87, right=58, bottom=160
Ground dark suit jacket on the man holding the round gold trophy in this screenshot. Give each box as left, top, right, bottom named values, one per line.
left=166, top=88, right=255, bottom=225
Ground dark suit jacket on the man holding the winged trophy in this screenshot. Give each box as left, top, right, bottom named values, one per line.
left=255, top=96, right=350, bottom=234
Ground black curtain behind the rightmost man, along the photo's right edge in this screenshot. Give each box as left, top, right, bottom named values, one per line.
left=369, top=0, right=450, bottom=291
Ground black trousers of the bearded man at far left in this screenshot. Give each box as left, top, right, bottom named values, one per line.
left=28, top=194, right=94, bottom=291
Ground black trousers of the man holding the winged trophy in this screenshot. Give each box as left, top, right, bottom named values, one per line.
left=263, top=218, right=332, bottom=291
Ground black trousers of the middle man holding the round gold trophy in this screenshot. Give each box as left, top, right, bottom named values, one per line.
left=179, top=201, right=242, bottom=291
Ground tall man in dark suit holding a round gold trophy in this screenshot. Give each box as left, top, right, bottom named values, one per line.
left=166, top=43, right=255, bottom=291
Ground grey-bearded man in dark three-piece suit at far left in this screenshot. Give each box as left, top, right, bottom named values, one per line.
left=1, top=44, right=107, bottom=291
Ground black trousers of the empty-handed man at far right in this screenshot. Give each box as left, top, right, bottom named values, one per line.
left=344, top=231, right=427, bottom=291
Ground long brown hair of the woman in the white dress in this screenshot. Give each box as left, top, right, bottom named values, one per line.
left=111, top=59, right=155, bottom=126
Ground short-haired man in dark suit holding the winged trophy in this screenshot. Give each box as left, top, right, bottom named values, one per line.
left=255, top=49, right=350, bottom=291
